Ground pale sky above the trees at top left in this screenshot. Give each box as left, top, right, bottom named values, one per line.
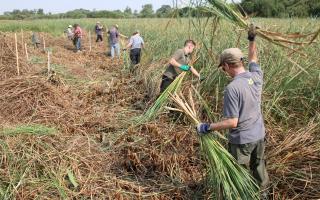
left=0, top=0, right=172, bottom=14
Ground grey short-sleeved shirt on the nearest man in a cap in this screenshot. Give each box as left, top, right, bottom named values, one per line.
left=223, top=62, right=265, bottom=144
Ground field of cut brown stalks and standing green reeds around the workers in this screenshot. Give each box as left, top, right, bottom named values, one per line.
left=0, top=18, right=320, bottom=199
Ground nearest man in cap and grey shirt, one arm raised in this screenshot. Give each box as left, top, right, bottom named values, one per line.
left=197, top=25, right=269, bottom=199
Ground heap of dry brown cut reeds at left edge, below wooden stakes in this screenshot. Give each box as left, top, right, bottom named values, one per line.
left=0, top=76, right=76, bottom=133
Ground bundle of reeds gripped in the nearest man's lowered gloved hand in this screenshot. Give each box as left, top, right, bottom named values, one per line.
left=170, top=93, right=259, bottom=200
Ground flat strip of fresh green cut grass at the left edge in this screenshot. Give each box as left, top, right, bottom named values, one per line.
left=0, top=124, right=57, bottom=136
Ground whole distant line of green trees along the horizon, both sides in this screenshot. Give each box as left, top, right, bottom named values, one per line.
left=0, top=0, right=320, bottom=20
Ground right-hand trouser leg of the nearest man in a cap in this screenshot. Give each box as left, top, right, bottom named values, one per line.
left=250, top=140, right=269, bottom=190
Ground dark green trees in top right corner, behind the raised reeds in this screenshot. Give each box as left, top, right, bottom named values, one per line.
left=240, top=0, right=320, bottom=17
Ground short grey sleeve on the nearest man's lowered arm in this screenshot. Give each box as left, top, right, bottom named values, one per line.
left=223, top=87, right=240, bottom=118
